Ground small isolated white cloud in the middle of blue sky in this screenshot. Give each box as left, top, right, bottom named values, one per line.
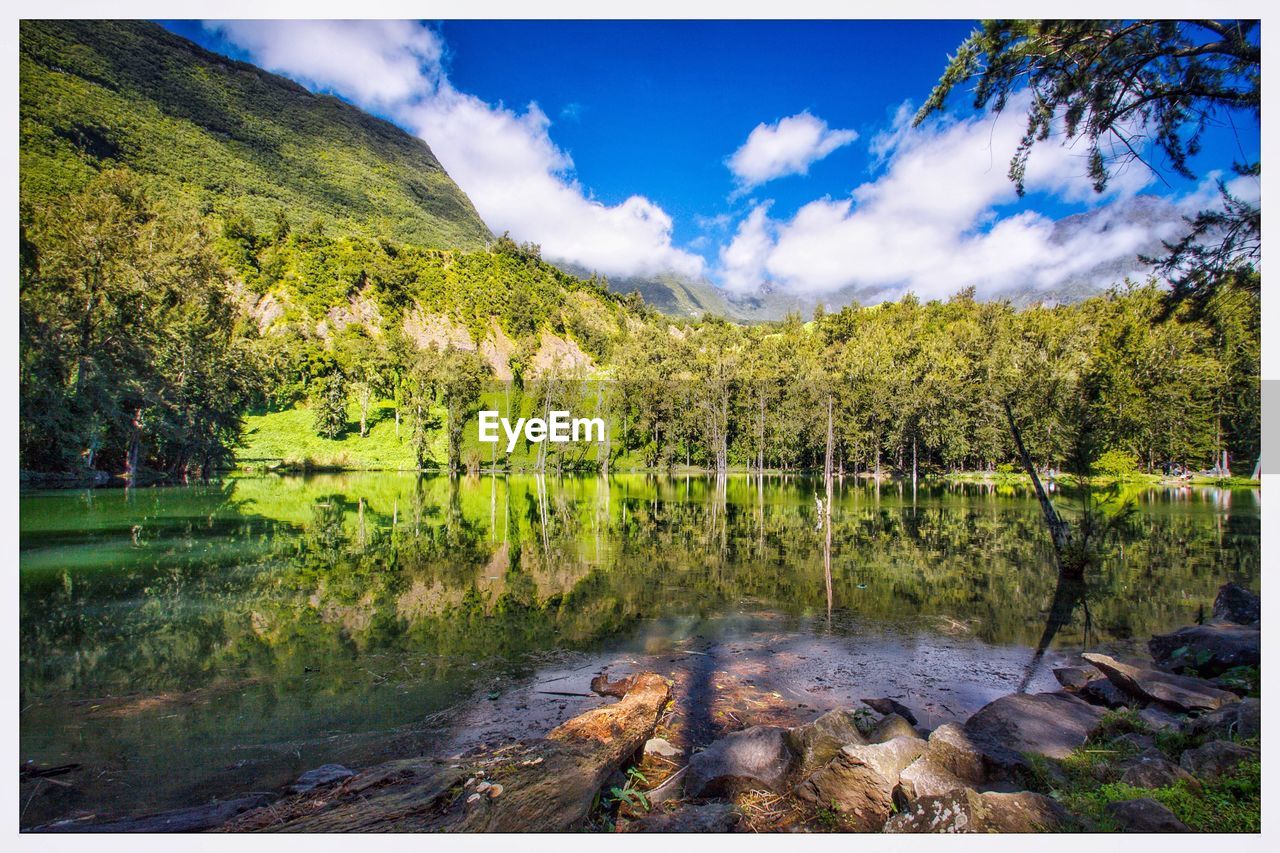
left=727, top=111, right=858, bottom=190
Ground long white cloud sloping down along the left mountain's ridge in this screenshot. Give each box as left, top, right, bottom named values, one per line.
left=206, top=20, right=704, bottom=277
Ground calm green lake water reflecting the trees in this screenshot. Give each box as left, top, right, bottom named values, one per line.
left=20, top=474, right=1260, bottom=826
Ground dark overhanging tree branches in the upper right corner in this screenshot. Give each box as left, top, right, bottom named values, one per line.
left=915, top=20, right=1262, bottom=297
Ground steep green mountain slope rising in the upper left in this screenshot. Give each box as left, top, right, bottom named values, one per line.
left=19, top=20, right=492, bottom=248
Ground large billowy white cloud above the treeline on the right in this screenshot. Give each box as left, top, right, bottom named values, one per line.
left=718, top=99, right=1178, bottom=298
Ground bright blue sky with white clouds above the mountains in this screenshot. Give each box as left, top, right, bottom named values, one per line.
left=165, top=20, right=1260, bottom=295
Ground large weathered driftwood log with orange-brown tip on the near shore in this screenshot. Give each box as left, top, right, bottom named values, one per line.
left=230, top=672, right=671, bottom=833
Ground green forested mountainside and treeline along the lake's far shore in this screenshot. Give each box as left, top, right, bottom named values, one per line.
left=19, top=22, right=1260, bottom=480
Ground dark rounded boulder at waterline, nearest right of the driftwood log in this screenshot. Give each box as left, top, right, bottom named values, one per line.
left=685, top=726, right=795, bottom=798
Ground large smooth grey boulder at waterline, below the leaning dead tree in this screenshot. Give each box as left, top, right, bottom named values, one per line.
left=964, top=691, right=1106, bottom=766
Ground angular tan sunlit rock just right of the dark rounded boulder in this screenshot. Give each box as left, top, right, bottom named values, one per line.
left=796, top=738, right=925, bottom=833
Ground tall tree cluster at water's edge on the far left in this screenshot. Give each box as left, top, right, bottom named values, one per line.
left=19, top=170, right=259, bottom=476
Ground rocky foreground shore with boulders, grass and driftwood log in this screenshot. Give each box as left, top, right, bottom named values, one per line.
left=30, top=584, right=1261, bottom=833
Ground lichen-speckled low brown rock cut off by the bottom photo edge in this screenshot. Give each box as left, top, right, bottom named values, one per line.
left=884, top=788, right=1070, bottom=833
